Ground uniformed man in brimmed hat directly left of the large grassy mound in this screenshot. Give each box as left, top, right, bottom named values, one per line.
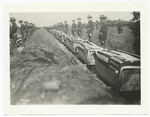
left=99, top=15, right=108, bottom=47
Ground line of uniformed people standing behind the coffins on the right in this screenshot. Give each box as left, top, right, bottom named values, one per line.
left=48, top=11, right=140, bottom=55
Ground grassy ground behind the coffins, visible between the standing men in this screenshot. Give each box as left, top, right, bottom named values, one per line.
left=69, top=27, right=134, bottom=53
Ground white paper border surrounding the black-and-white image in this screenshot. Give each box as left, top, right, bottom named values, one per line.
left=1, top=0, right=148, bottom=114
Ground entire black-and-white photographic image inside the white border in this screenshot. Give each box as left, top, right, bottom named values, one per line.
left=8, top=11, right=141, bottom=105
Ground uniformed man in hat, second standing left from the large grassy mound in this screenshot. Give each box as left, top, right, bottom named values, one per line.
left=87, top=15, right=94, bottom=42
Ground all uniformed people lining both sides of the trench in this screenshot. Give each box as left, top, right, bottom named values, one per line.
left=10, top=11, right=140, bottom=55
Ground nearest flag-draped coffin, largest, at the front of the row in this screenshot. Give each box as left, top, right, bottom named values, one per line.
left=94, top=50, right=141, bottom=91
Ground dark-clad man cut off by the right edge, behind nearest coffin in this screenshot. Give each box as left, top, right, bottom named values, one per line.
left=132, top=11, right=140, bottom=55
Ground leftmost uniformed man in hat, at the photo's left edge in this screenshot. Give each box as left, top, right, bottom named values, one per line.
left=10, top=17, right=17, bottom=56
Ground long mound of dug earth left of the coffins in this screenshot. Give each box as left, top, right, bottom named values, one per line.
left=10, top=29, right=126, bottom=105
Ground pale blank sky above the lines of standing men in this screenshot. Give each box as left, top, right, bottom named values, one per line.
left=10, top=11, right=133, bottom=26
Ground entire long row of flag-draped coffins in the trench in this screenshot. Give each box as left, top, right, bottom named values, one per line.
left=49, top=30, right=141, bottom=91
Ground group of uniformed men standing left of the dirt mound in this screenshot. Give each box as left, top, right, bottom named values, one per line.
left=10, top=17, right=36, bottom=56
